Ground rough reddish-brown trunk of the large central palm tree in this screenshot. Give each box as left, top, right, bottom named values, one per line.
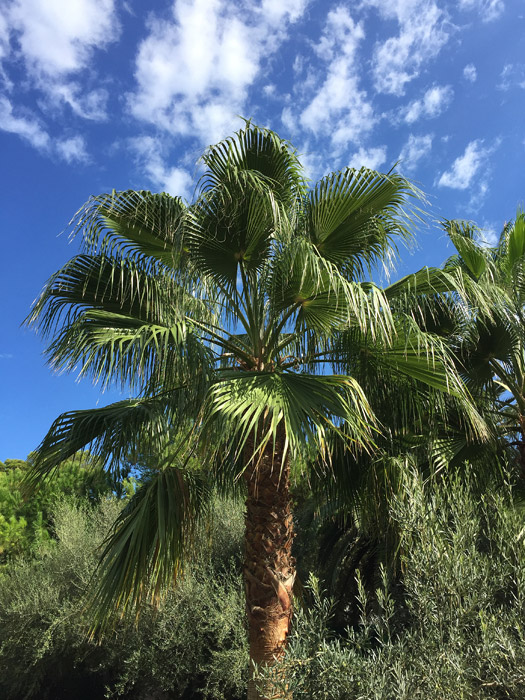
left=244, top=439, right=295, bottom=700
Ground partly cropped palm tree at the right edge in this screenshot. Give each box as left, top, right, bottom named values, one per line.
left=444, top=216, right=525, bottom=481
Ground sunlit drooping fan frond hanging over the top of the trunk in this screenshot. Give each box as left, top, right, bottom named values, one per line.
left=203, top=372, right=375, bottom=469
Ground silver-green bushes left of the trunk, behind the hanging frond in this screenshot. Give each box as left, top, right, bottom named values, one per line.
left=0, top=499, right=247, bottom=700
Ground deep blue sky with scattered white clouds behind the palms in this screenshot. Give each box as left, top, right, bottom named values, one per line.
left=0, top=0, right=525, bottom=460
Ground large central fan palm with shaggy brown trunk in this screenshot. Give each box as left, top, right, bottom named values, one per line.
left=28, top=123, right=482, bottom=699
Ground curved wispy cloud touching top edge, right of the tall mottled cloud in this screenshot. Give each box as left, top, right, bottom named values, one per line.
left=363, top=0, right=452, bottom=95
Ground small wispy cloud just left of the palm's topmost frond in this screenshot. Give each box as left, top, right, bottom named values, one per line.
left=130, top=136, right=194, bottom=199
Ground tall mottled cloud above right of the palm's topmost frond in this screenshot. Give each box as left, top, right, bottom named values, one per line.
left=299, top=7, right=377, bottom=150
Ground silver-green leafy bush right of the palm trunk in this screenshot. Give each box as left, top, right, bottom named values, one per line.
left=264, top=477, right=525, bottom=700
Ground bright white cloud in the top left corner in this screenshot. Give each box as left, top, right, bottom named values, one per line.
left=7, top=0, right=119, bottom=78
